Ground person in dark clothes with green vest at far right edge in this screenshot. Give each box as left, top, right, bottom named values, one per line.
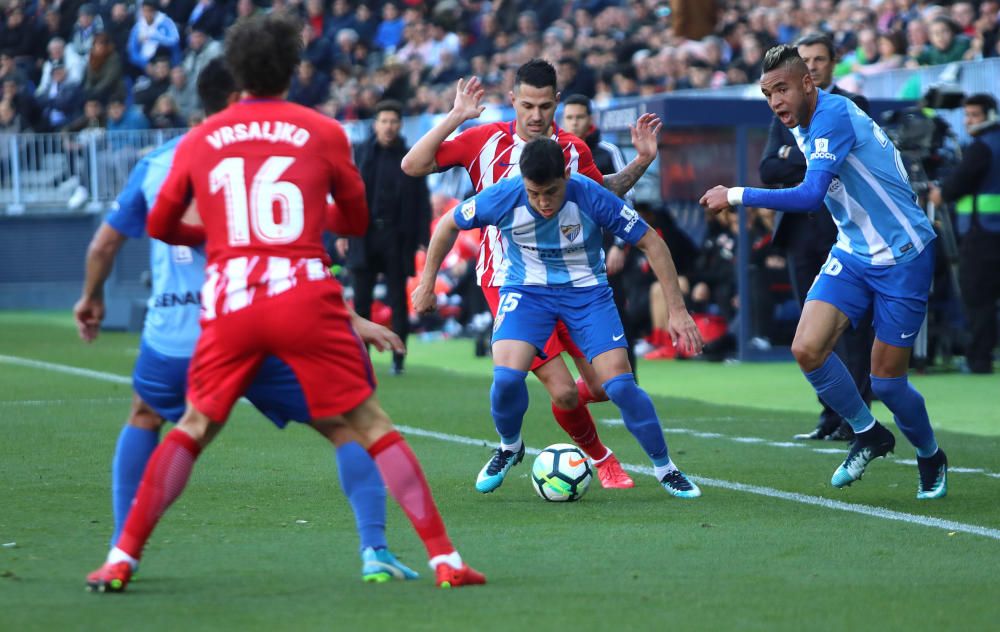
left=930, top=94, right=1000, bottom=373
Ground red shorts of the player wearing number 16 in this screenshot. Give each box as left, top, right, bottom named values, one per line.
left=188, top=279, right=375, bottom=423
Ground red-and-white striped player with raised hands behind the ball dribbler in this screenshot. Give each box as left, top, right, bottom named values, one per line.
left=402, top=59, right=660, bottom=488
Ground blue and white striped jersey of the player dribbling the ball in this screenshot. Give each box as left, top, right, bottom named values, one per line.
left=454, top=173, right=649, bottom=287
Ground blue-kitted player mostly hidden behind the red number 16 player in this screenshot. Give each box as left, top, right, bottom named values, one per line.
left=73, top=58, right=417, bottom=581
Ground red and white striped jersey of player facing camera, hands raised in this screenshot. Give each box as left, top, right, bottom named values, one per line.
left=434, top=121, right=604, bottom=287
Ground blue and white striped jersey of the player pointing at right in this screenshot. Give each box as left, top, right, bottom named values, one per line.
left=792, top=90, right=935, bottom=265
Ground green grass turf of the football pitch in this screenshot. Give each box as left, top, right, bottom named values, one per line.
left=0, top=314, right=1000, bottom=631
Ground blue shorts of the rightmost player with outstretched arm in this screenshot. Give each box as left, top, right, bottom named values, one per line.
left=806, top=241, right=934, bottom=347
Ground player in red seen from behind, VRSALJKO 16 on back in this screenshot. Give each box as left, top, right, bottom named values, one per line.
left=87, top=14, right=485, bottom=590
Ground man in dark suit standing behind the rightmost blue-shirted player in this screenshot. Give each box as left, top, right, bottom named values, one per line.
left=760, top=34, right=872, bottom=440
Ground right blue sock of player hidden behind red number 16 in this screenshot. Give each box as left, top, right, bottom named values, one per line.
left=337, top=441, right=386, bottom=549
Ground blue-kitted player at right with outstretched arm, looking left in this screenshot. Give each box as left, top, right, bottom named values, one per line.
left=701, top=46, right=948, bottom=498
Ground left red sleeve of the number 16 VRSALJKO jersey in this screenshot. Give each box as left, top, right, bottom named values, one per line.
left=146, top=134, right=205, bottom=246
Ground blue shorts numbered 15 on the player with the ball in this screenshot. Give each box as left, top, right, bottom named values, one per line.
left=493, top=285, right=628, bottom=362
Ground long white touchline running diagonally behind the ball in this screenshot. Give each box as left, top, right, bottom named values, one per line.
left=0, top=354, right=1000, bottom=540
